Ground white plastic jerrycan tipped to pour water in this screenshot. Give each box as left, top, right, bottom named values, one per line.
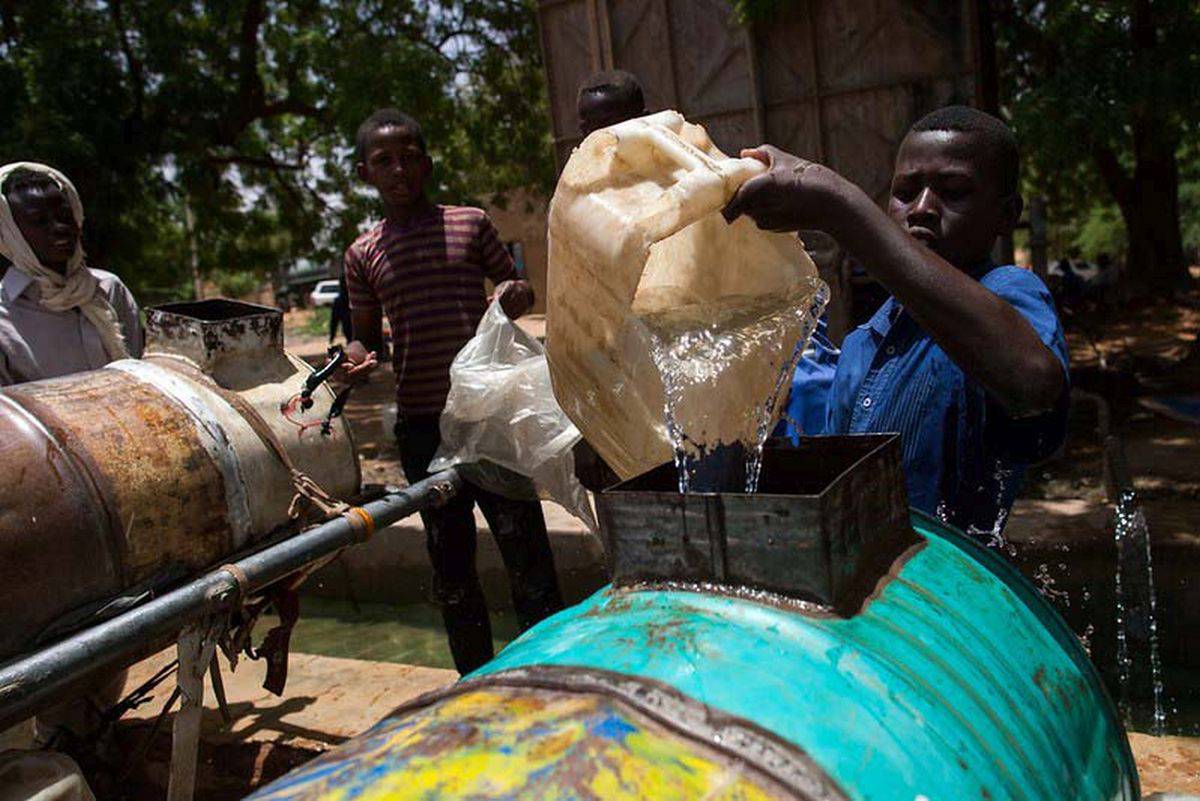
left=546, top=112, right=823, bottom=478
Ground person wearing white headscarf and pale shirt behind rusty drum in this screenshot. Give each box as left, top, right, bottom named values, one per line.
left=0, top=162, right=142, bottom=386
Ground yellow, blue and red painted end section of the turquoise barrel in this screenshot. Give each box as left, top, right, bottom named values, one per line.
left=249, top=687, right=794, bottom=801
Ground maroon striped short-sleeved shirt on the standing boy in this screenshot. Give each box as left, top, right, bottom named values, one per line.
left=344, top=206, right=517, bottom=415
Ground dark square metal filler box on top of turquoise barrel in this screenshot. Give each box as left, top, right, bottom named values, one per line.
left=596, top=434, right=920, bottom=616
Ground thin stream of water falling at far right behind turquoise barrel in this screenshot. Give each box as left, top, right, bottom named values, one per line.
left=1114, top=489, right=1166, bottom=735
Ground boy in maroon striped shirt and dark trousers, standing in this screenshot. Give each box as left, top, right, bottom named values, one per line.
left=346, top=109, right=563, bottom=674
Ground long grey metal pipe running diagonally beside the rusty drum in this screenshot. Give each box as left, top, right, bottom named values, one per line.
left=0, top=469, right=462, bottom=730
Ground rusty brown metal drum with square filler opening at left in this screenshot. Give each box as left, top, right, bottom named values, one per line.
left=0, top=300, right=360, bottom=660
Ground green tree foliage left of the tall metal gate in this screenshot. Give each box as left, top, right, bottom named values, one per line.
left=0, top=0, right=554, bottom=299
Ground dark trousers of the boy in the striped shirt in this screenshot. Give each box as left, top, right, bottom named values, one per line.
left=396, top=415, right=563, bottom=674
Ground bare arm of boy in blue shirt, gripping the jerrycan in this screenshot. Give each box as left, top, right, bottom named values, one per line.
left=725, top=145, right=1064, bottom=417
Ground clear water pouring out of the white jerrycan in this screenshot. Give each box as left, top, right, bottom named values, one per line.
left=643, top=281, right=829, bottom=493
